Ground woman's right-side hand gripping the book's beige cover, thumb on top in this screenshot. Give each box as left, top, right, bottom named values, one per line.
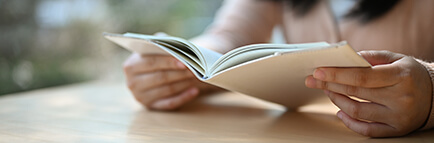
left=305, top=51, right=433, bottom=137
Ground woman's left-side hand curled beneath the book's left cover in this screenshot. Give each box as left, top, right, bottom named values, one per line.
left=124, top=54, right=220, bottom=110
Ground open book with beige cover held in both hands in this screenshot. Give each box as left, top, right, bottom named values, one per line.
left=104, top=33, right=371, bottom=108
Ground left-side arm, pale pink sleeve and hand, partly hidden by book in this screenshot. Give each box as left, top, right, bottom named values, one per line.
left=124, top=0, right=280, bottom=110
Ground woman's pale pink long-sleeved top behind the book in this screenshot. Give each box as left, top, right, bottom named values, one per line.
left=194, top=0, right=434, bottom=131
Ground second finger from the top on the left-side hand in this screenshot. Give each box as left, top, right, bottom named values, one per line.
left=128, top=70, right=194, bottom=90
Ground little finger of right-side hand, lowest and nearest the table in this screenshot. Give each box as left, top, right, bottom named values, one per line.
left=337, top=111, right=399, bottom=137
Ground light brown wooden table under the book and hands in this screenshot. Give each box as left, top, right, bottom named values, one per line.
left=0, top=82, right=434, bottom=143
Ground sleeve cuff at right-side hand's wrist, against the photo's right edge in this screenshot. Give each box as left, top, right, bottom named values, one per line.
left=417, top=60, right=434, bottom=130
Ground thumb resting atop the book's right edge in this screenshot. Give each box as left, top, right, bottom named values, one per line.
left=358, top=51, right=405, bottom=66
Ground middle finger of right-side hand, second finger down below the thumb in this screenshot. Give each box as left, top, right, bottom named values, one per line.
left=305, top=76, right=391, bottom=105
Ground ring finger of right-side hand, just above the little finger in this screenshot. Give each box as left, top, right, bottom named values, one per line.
left=328, top=92, right=391, bottom=123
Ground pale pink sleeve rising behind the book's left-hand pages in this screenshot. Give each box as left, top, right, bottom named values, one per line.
left=192, top=0, right=283, bottom=53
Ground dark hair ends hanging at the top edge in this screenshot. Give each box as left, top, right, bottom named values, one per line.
left=283, top=0, right=401, bottom=23
